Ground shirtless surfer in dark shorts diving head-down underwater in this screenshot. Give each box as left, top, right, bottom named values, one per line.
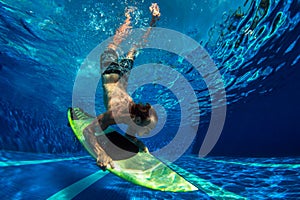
left=84, top=3, right=160, bottom=170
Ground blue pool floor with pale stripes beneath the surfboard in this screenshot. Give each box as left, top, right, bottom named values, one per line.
left=0, top=151, right=300, bottom=199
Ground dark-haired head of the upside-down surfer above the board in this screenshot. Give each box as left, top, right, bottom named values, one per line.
left=130, top=103, right=158, bottom=136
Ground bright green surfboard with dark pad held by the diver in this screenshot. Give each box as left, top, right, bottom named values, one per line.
left=68, top=108, right=198, bottom=192
